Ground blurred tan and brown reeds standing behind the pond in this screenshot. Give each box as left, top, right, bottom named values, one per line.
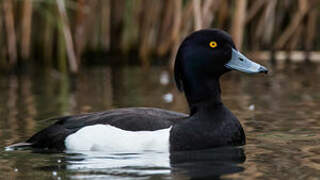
left=0, top=0, right=320, bottom=73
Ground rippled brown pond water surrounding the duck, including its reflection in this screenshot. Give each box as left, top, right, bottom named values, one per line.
left=0, top=63, right=320, bottom=180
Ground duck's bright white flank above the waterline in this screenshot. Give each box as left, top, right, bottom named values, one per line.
left=65, top=124, right=171, bottom=152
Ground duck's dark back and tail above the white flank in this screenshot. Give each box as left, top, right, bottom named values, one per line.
left=27, top=108, right=188, bottom=151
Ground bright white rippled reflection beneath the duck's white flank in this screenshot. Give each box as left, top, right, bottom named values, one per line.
left=66, top=151, right=170, bottom=176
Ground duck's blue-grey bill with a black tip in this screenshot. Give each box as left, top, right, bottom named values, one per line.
left=225, top=48, right=268, bottom=74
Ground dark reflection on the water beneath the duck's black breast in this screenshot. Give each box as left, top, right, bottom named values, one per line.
left=170, top=147, right=246, bottom=179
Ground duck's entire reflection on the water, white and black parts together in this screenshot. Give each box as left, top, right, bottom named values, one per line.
left=65, top=147, right=246, bottom=179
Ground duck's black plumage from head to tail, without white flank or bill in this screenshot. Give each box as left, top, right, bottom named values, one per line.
left=9, top=29, right=267, bottom=151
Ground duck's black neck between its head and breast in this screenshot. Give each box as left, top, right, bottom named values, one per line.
left=185, top=77, right=222, bottom=115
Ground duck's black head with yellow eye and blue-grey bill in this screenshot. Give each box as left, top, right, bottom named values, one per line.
left=174, top=29, right=267, bottom=105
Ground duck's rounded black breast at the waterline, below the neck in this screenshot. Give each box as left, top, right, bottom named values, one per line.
left=170, top=104, right=245, bottom=151
